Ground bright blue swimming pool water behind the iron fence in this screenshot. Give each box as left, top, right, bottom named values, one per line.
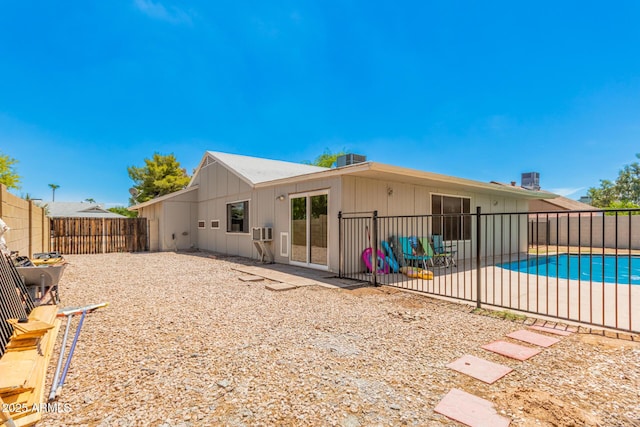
left=498, top=254, right=640, bottom=285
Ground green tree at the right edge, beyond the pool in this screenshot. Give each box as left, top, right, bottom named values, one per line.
left=587, top=154, right=640, bottom=209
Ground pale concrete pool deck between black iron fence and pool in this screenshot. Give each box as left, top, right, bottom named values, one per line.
left=370, top=260, right=640, bottom=333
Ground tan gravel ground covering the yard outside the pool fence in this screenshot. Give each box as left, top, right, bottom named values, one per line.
left=42, top=253, right=640, bottom=426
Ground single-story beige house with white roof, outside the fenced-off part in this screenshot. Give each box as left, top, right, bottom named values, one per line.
left=130, top=151, right=556, bottom=272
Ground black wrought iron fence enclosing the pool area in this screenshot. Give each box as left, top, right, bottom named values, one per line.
left=339, top=209, right=640, bottom=332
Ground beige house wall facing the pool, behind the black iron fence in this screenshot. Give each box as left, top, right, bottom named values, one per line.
left=341, top=176, right=529, bottom=258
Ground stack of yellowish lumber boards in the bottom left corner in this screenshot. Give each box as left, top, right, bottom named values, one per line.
left=0, top=305, right=61, bottom=427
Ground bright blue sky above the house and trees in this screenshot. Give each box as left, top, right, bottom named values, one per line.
left=0, top=0, right=640, bottom=206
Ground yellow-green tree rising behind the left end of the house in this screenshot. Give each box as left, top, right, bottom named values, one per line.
left=127, top=153, right=190, bottom=204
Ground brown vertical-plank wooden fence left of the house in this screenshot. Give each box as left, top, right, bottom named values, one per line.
left=51, top=218, right=149, bottom=255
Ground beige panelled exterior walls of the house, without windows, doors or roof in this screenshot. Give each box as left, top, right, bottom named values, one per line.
left=141, top=162, right=529, bottom=272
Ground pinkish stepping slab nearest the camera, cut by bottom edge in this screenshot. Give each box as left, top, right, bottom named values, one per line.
left=434, top=388, right=511, bottom=427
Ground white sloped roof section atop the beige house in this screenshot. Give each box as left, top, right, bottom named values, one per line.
left=203, top=151, right=328, bottom=185
